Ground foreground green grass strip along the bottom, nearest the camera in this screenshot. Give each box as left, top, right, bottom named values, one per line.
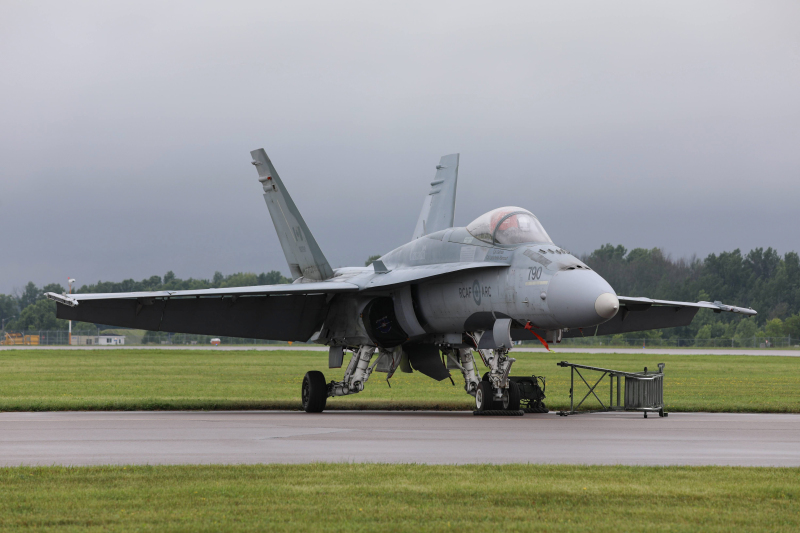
left=0, top=464, right=800, bottom=532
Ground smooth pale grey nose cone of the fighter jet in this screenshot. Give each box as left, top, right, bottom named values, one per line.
left=547, top=269, right=619, bottom=328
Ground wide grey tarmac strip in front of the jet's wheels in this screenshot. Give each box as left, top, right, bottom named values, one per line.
left=0, top=411, right=800, bottom=466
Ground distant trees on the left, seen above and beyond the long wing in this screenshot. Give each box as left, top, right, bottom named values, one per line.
left=0, top=270, right=291, bottom=333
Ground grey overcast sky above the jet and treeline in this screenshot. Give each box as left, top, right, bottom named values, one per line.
left=0, top=0, right=800, bottom=293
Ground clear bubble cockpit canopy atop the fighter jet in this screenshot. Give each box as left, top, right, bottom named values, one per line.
left=467, top=207, right=553, bottom=244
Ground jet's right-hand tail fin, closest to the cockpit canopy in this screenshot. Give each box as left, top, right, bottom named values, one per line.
left=411, top=154, right=459, bottom=240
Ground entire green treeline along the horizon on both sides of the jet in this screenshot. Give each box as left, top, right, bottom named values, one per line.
left=0, top=244, right=800, bottom=340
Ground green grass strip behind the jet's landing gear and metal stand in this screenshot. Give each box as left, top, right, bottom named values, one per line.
left=0, top=349, right=800, bottom=413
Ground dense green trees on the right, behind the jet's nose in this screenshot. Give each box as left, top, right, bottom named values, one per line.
left=581, top=244, right=800, bottom=339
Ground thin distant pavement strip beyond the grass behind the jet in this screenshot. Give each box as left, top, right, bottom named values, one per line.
left=0, top=344, right=800, bottom=357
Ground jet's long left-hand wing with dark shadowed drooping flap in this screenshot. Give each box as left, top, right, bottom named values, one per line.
left=45, top=282, right=359, bottom=341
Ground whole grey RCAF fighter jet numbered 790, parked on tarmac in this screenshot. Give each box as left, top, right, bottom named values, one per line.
left=46, top=149, right=756, bottom=412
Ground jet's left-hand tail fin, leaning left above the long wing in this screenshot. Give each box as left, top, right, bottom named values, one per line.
left=250, top=148, right=333, bottom=280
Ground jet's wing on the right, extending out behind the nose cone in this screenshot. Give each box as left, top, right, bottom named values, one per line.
left=564, top=296, right=757, bottom=337
